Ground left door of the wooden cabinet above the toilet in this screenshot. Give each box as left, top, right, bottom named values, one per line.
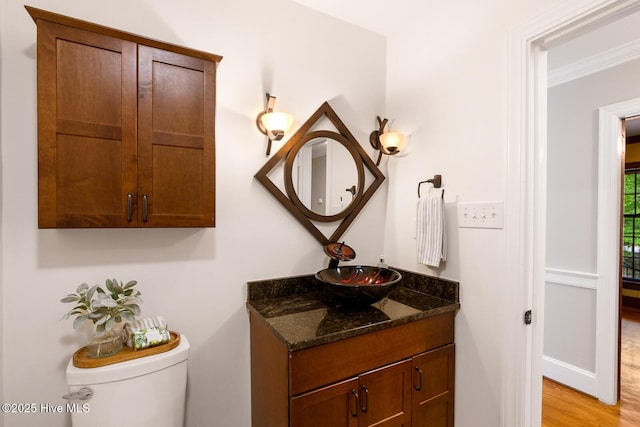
left=38, top=21, right=137, bottom=228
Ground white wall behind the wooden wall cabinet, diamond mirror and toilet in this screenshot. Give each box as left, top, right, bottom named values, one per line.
left=0, top=0, right=387, bottom=427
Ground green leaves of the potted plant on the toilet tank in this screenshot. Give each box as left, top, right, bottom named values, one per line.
left=60, top=279, right=142, bottom=337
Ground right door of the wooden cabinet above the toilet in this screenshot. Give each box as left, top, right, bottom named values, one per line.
left=138, top=46, right=215, bottom=227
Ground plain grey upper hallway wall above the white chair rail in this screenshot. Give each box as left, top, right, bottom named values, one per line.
left=547, top=61, right=640, bottom=273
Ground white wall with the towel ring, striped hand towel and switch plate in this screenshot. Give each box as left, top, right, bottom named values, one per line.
left=385, top=0, right=560, bottom=427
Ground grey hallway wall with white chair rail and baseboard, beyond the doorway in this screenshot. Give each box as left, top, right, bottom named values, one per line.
left=544, top=60, right=640, bottom=394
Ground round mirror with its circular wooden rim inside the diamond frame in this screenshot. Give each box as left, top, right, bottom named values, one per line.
left=284, top=131, right=364, bottom=222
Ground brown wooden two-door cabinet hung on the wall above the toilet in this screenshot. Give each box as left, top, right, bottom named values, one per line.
left=26, top=6, right=221, bottom=228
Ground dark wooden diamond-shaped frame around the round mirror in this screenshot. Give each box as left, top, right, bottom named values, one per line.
left=255, top=102, right=385, bottom=246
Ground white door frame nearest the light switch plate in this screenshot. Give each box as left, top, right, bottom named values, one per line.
left=501, top=0, right=640, bottom=427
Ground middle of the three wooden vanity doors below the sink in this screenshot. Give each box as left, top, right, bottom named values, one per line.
left=359, top=360, right=412, bottom=427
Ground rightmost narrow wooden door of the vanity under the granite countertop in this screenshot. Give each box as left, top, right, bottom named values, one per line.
left=412, top=344, right=455, bottom=427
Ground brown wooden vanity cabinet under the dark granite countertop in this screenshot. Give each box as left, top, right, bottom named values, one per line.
left=250, top=313, right=455, bottom=427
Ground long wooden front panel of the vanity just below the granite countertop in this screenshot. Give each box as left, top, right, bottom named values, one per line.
left=289, top=312, right=454, bottom=396
